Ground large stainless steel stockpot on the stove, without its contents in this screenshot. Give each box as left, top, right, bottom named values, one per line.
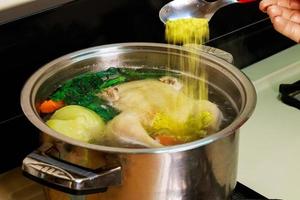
left=21, top=43, right=256, bottom=200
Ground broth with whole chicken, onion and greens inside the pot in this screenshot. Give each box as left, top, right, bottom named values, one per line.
left=40, top=68, right=237, bottom=147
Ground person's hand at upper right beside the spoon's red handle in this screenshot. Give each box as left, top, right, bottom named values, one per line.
left=259, top=0, right=300, bottom=43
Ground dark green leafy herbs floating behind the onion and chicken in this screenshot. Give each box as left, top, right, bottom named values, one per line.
left=50, top=68, right=178, bottom=121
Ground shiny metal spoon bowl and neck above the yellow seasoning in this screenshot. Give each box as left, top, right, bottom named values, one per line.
left=159, top=0, right=255, bottom=23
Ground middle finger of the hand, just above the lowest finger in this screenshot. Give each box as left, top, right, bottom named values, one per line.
left=267, top=5, right=300, bottom=23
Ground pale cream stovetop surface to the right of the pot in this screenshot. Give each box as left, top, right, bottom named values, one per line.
left=238, top=44, right=300, bottom=200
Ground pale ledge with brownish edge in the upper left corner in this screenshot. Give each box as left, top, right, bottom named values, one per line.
left=0, top=0, right=73, bottom=24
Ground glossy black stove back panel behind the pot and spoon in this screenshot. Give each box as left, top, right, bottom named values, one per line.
left=0, top=0, right=294, bottom=173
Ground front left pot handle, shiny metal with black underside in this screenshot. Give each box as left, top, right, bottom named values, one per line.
left=22, top=144, right=121, bottom=195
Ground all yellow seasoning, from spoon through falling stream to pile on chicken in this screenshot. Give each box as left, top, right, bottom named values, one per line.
left=149, top=18, right=213, bottom=145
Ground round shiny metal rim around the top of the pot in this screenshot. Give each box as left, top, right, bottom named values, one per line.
left=20, top=42, right=256, bottom=154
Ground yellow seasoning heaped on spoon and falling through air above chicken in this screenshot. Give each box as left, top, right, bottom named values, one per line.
left=165, top=18, right=209, bottom=100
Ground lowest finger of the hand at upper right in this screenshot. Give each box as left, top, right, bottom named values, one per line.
left=271, top=16, right=300, bottom=43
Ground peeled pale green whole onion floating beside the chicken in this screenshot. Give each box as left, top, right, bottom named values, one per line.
left=46, top=105, right=105, bottom=143
